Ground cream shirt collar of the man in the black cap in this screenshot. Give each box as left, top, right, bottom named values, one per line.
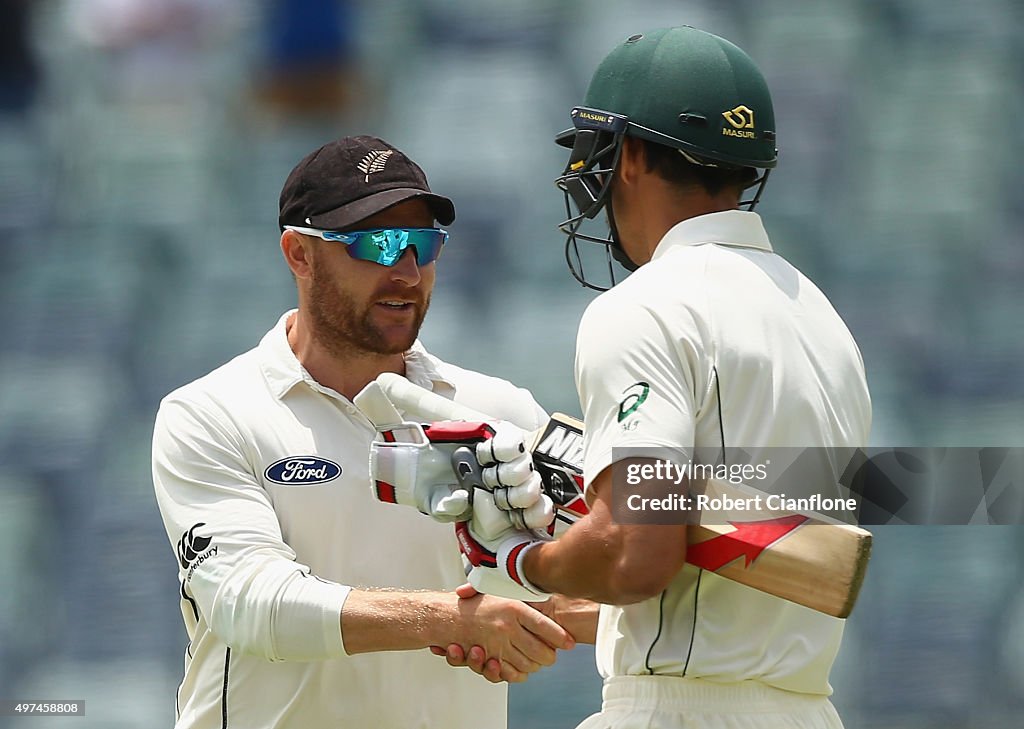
left=259, top=309, right=455, bottom=399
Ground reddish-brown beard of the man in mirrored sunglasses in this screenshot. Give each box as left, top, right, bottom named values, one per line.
left=309, top=273, right=430, bottom=356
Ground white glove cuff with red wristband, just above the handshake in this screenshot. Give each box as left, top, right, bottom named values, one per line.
left=456, top=489, right=551, bottom=602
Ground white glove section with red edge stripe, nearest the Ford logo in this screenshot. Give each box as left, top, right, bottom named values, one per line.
left=370, top=423, right=471, bottom=522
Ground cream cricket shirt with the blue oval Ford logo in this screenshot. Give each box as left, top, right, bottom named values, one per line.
left=153, top=312, right=546, bottom=729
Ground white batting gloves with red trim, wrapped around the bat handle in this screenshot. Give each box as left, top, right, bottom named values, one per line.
left=356, top=383, right=555, bottom=602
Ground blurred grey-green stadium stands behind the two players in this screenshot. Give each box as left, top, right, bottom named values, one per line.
left=0, top=0, right=1024, bottom=729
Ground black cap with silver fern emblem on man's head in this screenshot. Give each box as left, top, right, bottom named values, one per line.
left=278, top=136, right=455, bottom=230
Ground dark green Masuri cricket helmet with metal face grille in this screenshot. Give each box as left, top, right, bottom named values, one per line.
left=555, top=26, right=777, bottom=291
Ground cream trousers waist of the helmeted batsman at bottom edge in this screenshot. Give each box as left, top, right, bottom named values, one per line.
left=577, top=676, right=843, bottom=729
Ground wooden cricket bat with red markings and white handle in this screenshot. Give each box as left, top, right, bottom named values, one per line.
left=368, top=373, right=871, bottom=617
